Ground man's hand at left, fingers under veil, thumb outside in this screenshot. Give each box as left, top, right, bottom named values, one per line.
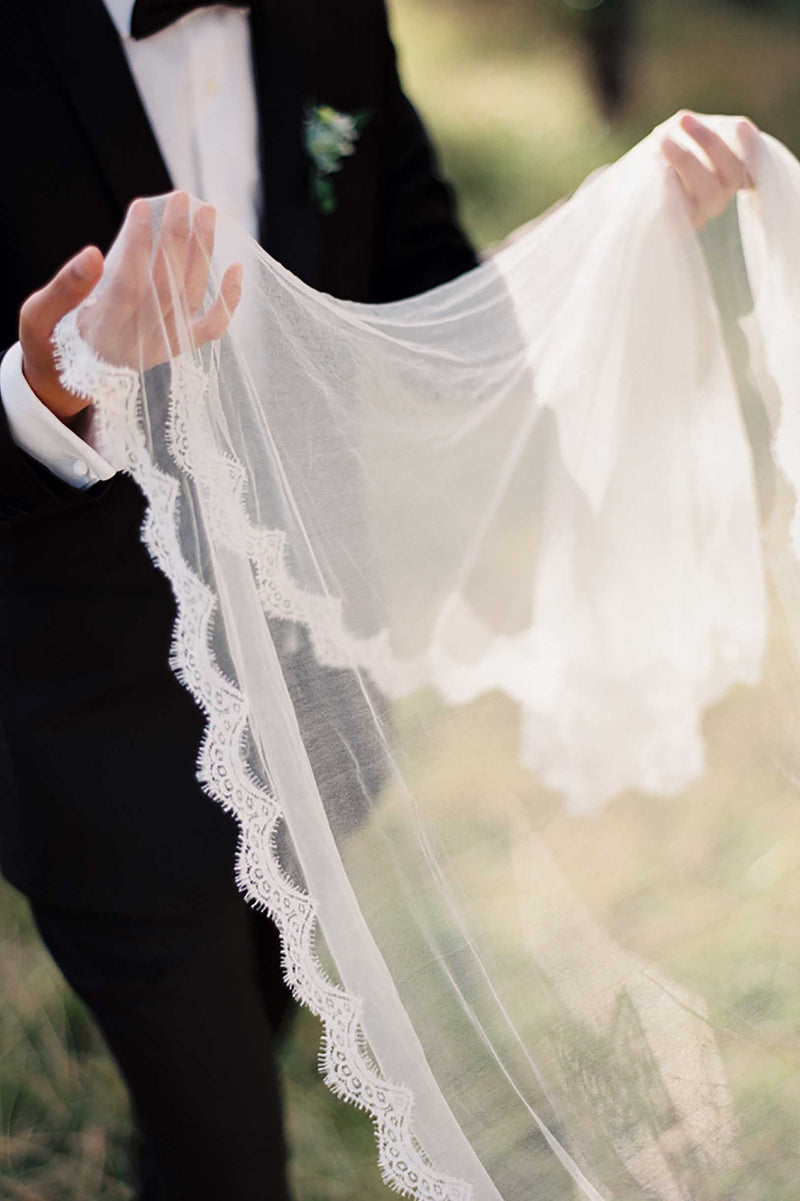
left=19, top=192, right=241, bottom=422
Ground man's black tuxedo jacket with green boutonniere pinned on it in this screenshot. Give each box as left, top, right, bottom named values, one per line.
left=0, top=0, right=474, bottom=913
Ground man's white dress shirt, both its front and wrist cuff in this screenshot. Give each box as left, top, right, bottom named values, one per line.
left=0, top=0, right=261, bottom=488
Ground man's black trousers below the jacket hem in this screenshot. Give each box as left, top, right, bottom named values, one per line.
left=31, top=885, right=293, bottom=1201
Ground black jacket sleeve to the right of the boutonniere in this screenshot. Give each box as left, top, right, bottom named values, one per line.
left=372, top=8, right=477, bottom=303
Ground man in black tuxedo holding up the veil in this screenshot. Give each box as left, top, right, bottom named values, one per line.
left=0, top=0, right=474, bottom=1201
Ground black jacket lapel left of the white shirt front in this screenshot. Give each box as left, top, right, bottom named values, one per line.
left=31, top=0, right=173, bottom=220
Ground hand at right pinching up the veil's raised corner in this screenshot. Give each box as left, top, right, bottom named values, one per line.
left=661, top=112, right=758, bottom=229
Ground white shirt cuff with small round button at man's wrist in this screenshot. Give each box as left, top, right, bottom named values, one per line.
left=0, top=342, right=115, bottom=488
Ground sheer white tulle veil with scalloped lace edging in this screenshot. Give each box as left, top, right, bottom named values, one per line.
left=56, top=120, right=800, bottom=1201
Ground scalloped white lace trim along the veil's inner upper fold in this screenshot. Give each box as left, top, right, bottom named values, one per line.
left=147, top=338, right=760, bottom=812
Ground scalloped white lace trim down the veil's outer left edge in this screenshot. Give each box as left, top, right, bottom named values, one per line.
left=53, top=312, right=473, bottom=1201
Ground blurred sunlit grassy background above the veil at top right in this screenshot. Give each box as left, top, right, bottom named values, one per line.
left=392, top=0, right=800, bottom=247
